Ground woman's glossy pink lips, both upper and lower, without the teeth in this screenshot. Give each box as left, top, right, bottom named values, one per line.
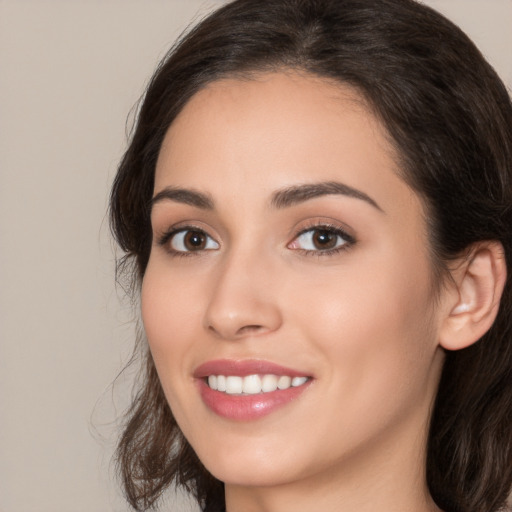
left=194, top=360, right=312, bottom=421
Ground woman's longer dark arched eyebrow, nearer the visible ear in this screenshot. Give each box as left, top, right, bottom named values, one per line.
left=270, top=181, right=384, bottom=213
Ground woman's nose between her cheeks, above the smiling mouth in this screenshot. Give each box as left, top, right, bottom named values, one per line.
left=204, top=248, right=282, bottom=340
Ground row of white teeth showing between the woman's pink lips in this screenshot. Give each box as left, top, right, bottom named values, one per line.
left=204, top=374, right=308, bottom=395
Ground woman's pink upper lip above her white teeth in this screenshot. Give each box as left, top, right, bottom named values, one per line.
left=194, top=359, right=310, bottom=379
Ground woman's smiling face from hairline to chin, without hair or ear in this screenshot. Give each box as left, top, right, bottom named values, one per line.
left=142, top=73, right=442, bottom=492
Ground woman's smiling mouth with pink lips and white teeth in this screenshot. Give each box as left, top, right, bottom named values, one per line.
left=194, top=360, right=314, bottom=421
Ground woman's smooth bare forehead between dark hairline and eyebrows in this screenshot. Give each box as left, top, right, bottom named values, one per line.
left=155, top=72, right=415, bottom=218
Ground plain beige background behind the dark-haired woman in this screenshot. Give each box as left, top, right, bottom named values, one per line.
left=0, top=0, right=512, bottom=512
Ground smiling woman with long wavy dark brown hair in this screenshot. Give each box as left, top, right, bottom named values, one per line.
left=111, top=0, right=512, bottom=512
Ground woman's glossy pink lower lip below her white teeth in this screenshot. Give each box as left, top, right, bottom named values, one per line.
left=198, top=379, right=311, bottom=421
